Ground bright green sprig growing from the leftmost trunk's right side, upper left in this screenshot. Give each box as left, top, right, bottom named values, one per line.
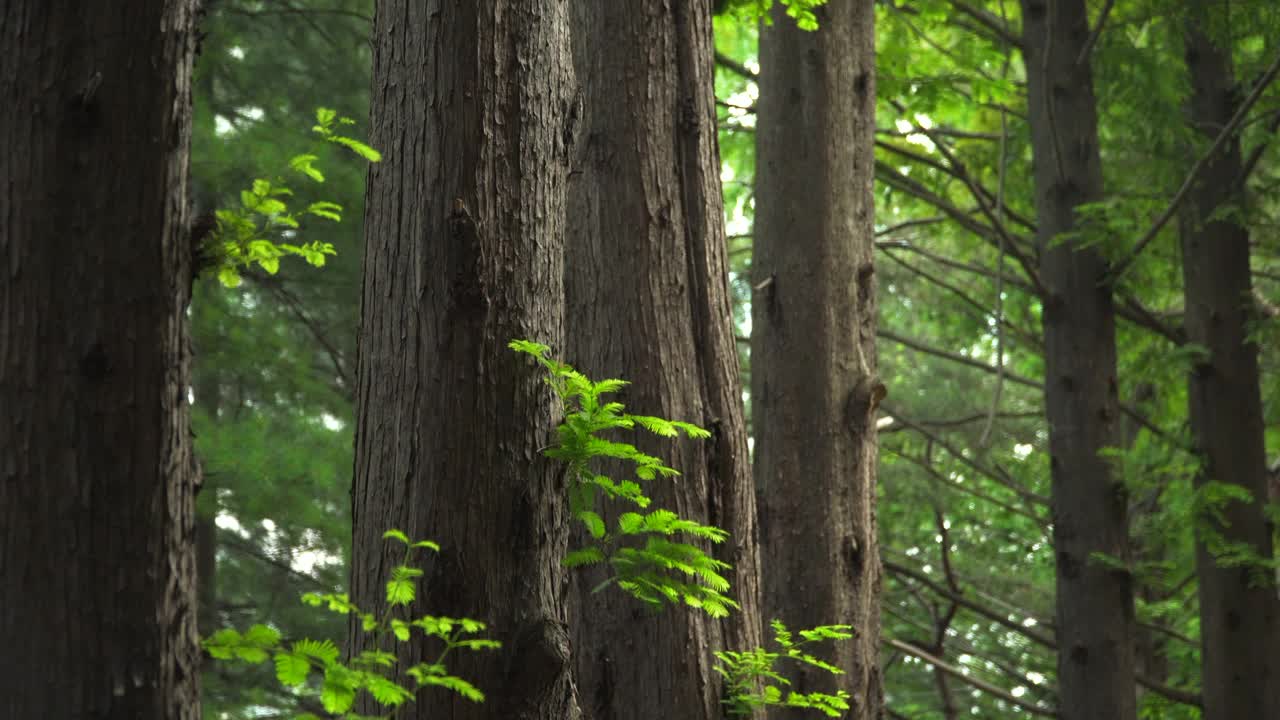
left=202, top=108, right=381, bottom=287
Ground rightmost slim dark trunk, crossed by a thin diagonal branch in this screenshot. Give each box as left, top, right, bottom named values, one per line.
left=1180, top=0, right=1280, bottom=720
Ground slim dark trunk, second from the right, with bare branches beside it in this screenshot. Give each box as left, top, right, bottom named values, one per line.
left=1023, top=0, right=1137, bottom=720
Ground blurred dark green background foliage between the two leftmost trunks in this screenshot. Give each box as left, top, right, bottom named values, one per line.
left=191, top=0, right=372, bottom=720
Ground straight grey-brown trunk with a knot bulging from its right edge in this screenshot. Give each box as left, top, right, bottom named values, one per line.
left=751, top=0, right=884, bottom=719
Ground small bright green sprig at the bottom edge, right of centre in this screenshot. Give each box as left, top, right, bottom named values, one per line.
left=716, top=620, right=854, bottom=717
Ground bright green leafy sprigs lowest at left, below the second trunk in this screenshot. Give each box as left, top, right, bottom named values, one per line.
left=204, top=529, right=500, bottom=720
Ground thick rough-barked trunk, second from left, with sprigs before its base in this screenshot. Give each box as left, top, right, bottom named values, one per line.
left=352, top=0, right=579, bottom=720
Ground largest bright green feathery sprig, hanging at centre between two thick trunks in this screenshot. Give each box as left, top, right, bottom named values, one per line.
left=509, top=340, right=737, bottom=618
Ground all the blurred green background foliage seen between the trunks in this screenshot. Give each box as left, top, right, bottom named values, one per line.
left=192, top=0, right=1280, bottom=720
